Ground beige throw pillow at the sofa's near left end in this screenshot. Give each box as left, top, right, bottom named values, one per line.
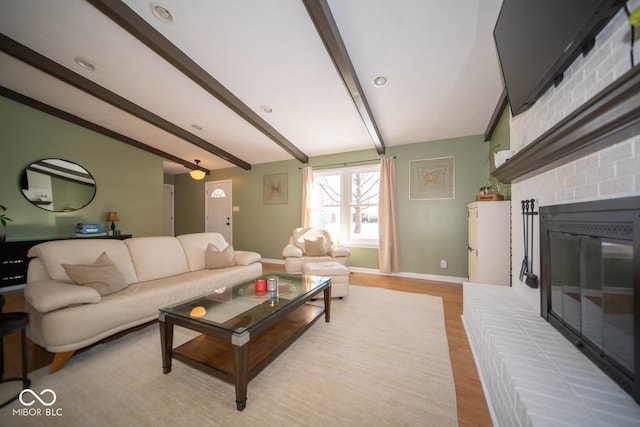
left=62, top=252, right=127, bottom=295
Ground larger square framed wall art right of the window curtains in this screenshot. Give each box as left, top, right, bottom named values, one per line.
left=409, top=157, right=456, bottom=200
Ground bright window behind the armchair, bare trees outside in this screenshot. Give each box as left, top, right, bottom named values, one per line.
left=312, top=165, right=380, bottom=247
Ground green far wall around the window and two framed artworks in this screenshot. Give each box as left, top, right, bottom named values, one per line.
left=175, top=136, right=489, bottom=277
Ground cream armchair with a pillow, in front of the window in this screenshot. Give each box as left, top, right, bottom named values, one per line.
left=282, top=228, right=351, bottom=274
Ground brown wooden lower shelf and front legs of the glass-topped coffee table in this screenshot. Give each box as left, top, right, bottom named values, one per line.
left=160, top=304, right=328, bottom=411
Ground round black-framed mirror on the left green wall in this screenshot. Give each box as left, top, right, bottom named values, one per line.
left=20, top=159, right=96, bottom=212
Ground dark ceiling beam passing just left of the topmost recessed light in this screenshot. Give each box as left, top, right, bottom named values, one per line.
left=87, top=0, right=309, bottom=163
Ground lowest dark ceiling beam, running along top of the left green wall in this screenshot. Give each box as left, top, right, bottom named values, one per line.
left=0, top=86, right=209, bottom=175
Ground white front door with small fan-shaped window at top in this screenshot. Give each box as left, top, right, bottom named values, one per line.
left=204, top=180, right=233, bottom=244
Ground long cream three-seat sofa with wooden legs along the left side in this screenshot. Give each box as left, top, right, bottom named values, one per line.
left=24, top=233, right=262, bottom=372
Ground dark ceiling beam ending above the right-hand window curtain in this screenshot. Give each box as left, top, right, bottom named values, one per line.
left=302, top=0, right=386, bottom=154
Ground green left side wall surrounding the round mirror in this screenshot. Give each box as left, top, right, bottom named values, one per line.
left=0, top=97, right=163, bottom=241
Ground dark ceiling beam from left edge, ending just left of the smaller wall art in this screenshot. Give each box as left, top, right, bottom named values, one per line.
left=0, top=34, right=251, bottom=170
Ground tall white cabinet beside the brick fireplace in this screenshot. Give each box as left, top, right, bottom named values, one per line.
left=467, top=202, right=511, bottom=286
